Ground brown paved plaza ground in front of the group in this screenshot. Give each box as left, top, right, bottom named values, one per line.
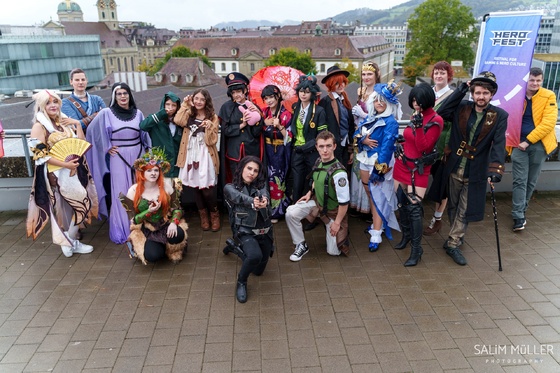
left=0, top=193, right=560, bottom=373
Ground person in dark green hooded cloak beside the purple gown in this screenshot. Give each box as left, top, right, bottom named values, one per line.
left=140, top=91, right=183, bottom=178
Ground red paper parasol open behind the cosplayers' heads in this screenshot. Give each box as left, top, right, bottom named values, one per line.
left=249, top=66, right=304, bottom=112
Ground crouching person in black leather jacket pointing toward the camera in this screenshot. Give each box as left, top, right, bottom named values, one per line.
left=224, top=156, right=273, bottom=303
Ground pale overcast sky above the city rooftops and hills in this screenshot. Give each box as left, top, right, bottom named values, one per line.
left=0, top=0, right=407, bottom=31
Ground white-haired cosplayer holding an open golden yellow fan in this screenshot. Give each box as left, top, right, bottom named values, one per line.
left=27, top=90, right=97, bottom=257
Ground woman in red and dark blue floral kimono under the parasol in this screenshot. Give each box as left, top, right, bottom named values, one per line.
left=261, top=85, right=292, bottom=223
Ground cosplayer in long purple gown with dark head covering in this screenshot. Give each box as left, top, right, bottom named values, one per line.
left=86, top=83, right=151, bottom=244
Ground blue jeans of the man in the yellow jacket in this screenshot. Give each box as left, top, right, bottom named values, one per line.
left=511, top=141, right=546, bottom=219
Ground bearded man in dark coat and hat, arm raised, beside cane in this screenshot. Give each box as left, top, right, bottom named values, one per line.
left=438, top=71, right=508, bottom=265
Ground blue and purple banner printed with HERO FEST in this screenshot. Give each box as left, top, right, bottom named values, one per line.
left=474, top=11, right=542, bottom=147
